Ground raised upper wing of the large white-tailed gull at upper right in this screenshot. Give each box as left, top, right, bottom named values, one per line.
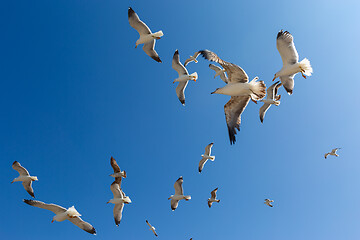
left=276, top=30, right=299, bottom=66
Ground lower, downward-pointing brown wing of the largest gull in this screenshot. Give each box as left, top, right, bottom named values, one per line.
left=224, top=96, right=250, bottom=144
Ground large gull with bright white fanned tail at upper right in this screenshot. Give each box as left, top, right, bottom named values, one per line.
left=273, top=30, right=313, bottom=95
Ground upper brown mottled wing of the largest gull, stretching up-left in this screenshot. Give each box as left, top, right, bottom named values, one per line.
left=199, top=50, right=249, bottom=83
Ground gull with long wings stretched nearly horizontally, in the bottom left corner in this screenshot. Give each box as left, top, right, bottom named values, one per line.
left=24, top=199, right=96, bottom=235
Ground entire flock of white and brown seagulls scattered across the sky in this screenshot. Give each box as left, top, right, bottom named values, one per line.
left=11, top=5, right=340, bottom=236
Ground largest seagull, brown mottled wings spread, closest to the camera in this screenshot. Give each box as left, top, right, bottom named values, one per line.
left=200, top=50, right=266, bottom=144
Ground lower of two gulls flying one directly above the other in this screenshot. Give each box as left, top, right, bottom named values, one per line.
left=107, top=178, right=131, bottom=226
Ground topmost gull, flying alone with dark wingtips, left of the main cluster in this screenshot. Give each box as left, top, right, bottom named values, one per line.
left=128, top=7, right=164, bottom=62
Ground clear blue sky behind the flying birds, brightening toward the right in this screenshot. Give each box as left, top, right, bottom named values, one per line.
left=0, top=0, right=360, bottom=240
